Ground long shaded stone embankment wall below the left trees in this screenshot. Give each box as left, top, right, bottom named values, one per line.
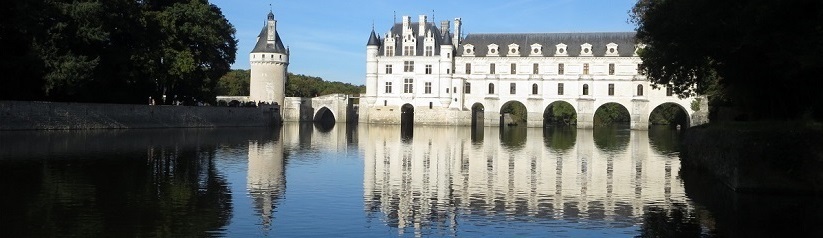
left=0, top=101, right=280, bottom=131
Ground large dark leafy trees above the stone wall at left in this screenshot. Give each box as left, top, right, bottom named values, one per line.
left=0, top=0, right=237, bottom=103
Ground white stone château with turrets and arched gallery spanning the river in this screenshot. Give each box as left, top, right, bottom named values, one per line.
left=359, top=15, right=706, bottom=129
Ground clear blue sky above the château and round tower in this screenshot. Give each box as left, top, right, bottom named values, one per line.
left=211, top=0, right=636, bottom=85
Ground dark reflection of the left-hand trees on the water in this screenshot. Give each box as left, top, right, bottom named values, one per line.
left=0, top=137, right=232, bottom=237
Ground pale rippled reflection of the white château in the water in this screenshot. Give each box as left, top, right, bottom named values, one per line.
left=359, top=125, right=692, bottom=231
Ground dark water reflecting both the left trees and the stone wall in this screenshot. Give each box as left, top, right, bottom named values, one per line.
left=0, top=130, right=270, bottom=237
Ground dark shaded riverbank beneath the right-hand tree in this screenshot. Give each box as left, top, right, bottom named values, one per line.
left=681, top=122, right=823, bottom=194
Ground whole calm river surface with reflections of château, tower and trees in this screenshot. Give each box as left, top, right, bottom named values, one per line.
left=0, top=124, right=823, bottom=237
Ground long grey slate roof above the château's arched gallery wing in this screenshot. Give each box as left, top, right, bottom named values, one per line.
left=457, top=32, right=636, bottom=57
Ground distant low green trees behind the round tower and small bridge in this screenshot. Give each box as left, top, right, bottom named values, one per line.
left=216, top=69, right=366, bottom=97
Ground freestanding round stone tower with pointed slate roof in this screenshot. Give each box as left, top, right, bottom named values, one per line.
left=249, top=12, right=289, bottom=106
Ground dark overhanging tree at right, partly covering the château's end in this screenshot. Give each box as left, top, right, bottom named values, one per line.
left=630, top=0, right=823, bottom=119
